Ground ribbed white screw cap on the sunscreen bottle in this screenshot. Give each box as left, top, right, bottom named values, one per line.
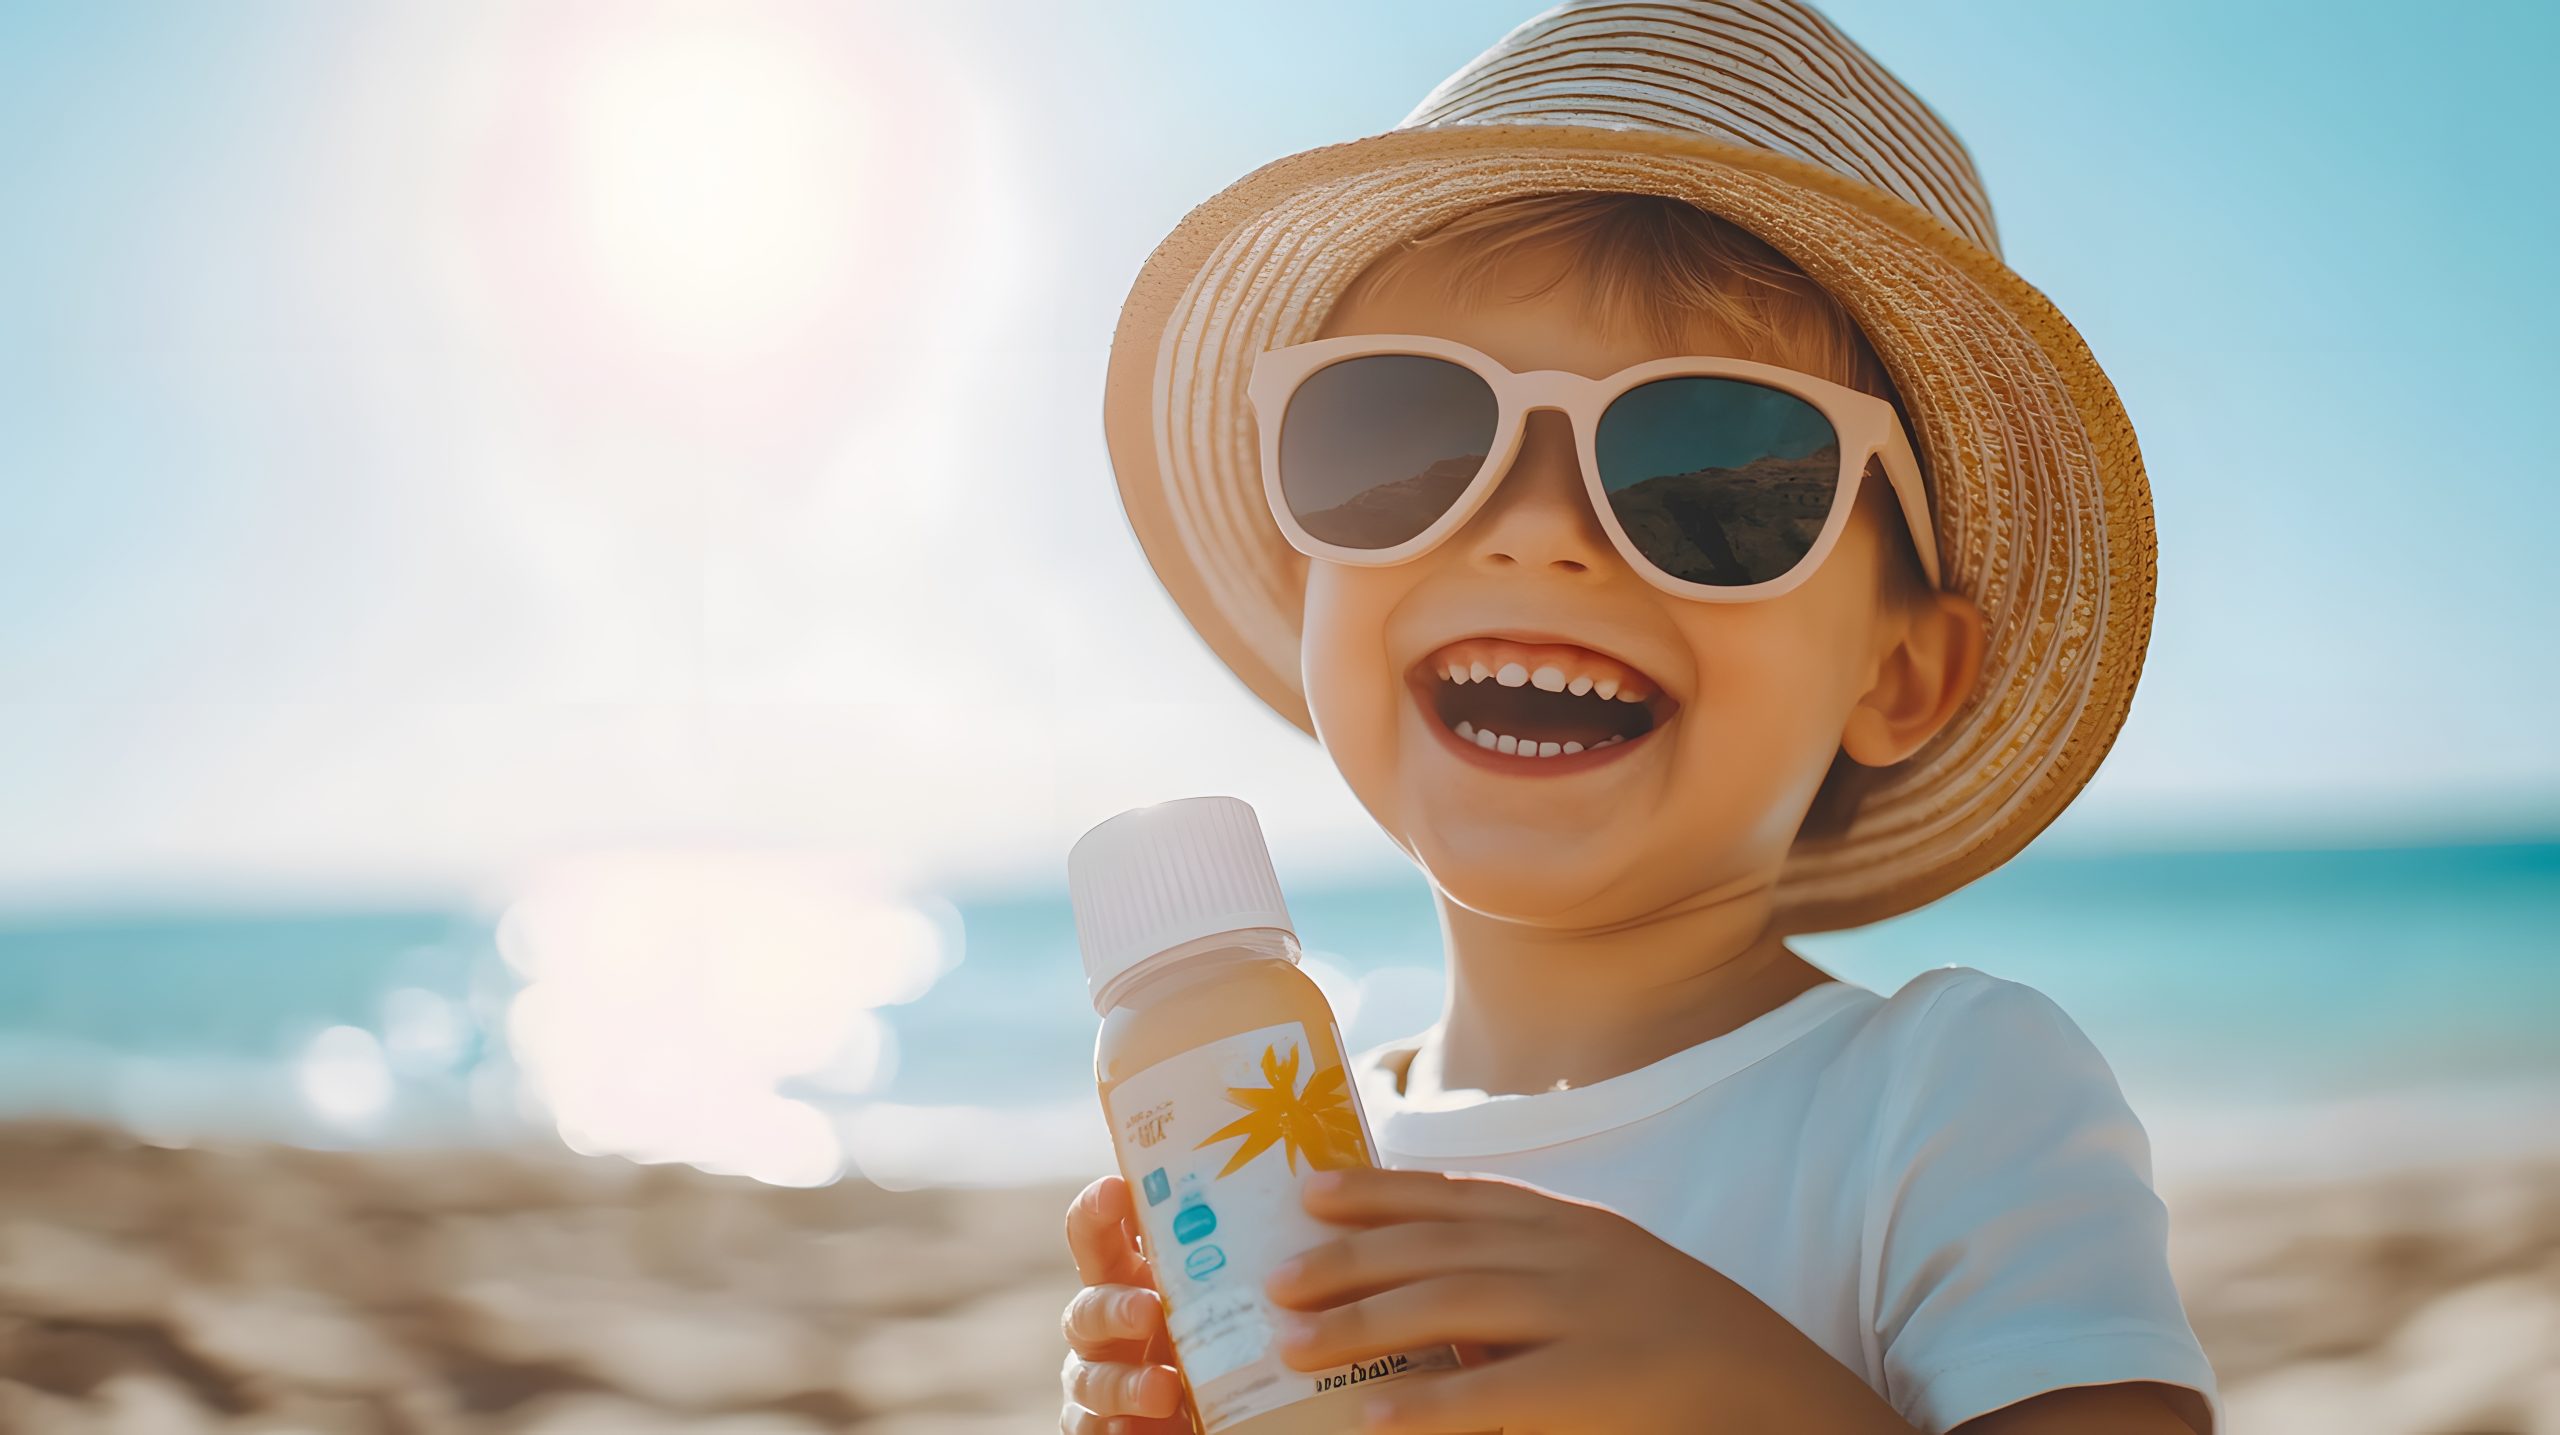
left=1068, top=798, right=1298, bottom=1008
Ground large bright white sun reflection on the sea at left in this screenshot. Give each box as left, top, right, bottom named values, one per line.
left=497, top=852, right=957, bottom=1187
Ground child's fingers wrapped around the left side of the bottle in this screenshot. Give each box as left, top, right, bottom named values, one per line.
left=1057, top=1177, right=1198, bottom=1435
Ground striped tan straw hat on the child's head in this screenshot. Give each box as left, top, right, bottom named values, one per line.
left=1103, top=0, right=2153, bottom=931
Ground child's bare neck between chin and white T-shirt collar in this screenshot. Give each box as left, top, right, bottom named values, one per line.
left=1416, top=872, right=1830, bottom=1095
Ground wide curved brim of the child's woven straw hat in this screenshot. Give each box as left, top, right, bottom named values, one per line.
left=1103, top=123, right=2156, bottom=931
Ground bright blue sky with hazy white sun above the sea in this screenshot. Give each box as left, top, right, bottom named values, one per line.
left=0, top=0, right=2560, bottom=900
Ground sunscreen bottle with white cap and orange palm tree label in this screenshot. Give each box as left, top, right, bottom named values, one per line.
left=1068, top=798, right=1459, bottom=1435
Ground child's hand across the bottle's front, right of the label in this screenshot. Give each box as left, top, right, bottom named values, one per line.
left=1265, top=1166, right=1846, bottom=1435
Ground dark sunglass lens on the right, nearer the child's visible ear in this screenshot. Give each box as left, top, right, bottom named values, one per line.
left=1592, top=379, right=1841, bottom=588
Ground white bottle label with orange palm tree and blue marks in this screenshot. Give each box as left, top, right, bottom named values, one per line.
left=1106, top=1021, right=1457, bottom=1435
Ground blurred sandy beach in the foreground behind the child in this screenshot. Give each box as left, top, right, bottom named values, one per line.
left=0, top=1123, right=2560, bottom=1435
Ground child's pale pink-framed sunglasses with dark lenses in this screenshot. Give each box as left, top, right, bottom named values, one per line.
left=1247, top=335, right=1938, bottom=604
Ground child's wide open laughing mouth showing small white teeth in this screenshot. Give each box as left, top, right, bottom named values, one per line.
left=1405, top=639, right=1679, bottom=760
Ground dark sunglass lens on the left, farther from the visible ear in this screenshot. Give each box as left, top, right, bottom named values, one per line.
left=1280, top=353, right=1498, bottom=547
